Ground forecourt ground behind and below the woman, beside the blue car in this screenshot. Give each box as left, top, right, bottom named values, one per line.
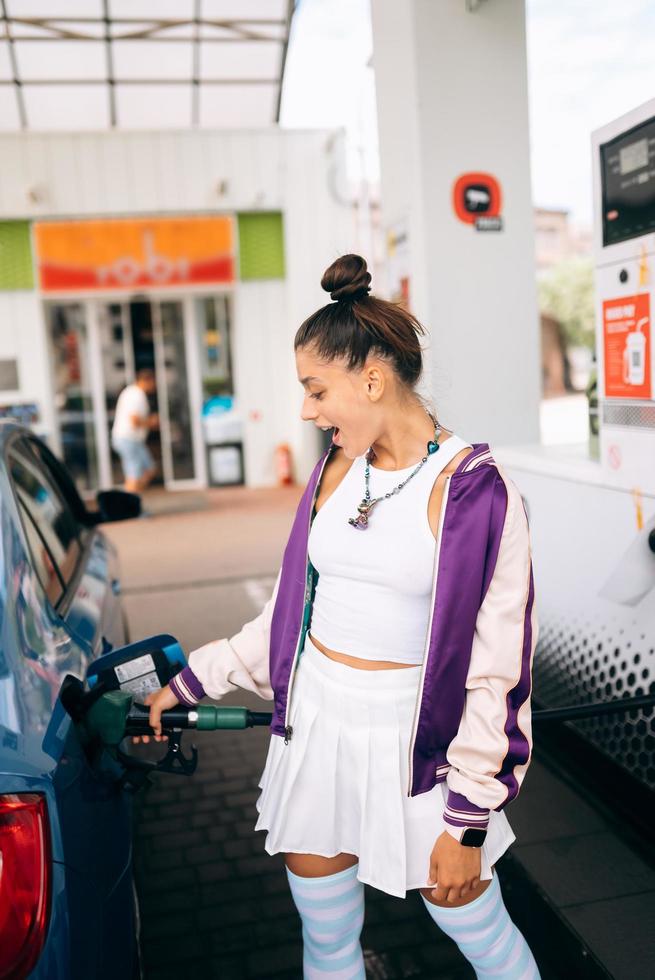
left=108, top=488, right=553, bottom=980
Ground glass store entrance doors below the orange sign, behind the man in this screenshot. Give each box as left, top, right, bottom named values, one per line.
left=44, top=296, right=200, bottom=492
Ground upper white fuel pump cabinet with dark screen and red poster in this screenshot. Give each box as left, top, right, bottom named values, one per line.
left=592, top=99, right=655, bottom=493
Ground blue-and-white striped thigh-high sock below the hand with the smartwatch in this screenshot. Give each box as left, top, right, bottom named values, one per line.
left=421, top=871, right=541, bottom=980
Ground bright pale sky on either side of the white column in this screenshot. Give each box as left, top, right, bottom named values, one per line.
left=281, top=0, right=655, bottom=225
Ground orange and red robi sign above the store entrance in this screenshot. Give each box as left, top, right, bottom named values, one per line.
left=34, top=216, right=234, bottom=292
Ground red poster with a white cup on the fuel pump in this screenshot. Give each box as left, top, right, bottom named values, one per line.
left=603, top=293, right=653, bottom=398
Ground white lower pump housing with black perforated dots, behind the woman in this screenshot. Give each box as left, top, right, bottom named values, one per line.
left=494, top=464, right=655, bottom=789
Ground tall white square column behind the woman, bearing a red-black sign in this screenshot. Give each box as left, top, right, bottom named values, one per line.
left=371, top=0, right=541, bottom=445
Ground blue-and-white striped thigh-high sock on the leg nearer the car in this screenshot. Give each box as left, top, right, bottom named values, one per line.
left=287, top=864, right=366, bottom=980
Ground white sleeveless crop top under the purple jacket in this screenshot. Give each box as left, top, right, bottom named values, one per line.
left=308, top=433, right=472, bottom=664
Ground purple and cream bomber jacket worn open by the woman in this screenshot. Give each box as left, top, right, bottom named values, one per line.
left=170, top=442, right=538, bottom=829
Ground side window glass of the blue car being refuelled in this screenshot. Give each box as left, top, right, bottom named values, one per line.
left=8, top=442, right=80, bottom=602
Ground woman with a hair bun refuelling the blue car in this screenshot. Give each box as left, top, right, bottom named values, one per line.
left=137, top=255, right=539, bottom=980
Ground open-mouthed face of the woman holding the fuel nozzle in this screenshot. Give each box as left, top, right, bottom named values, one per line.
left=296, top=348, right=384, bottom=459
